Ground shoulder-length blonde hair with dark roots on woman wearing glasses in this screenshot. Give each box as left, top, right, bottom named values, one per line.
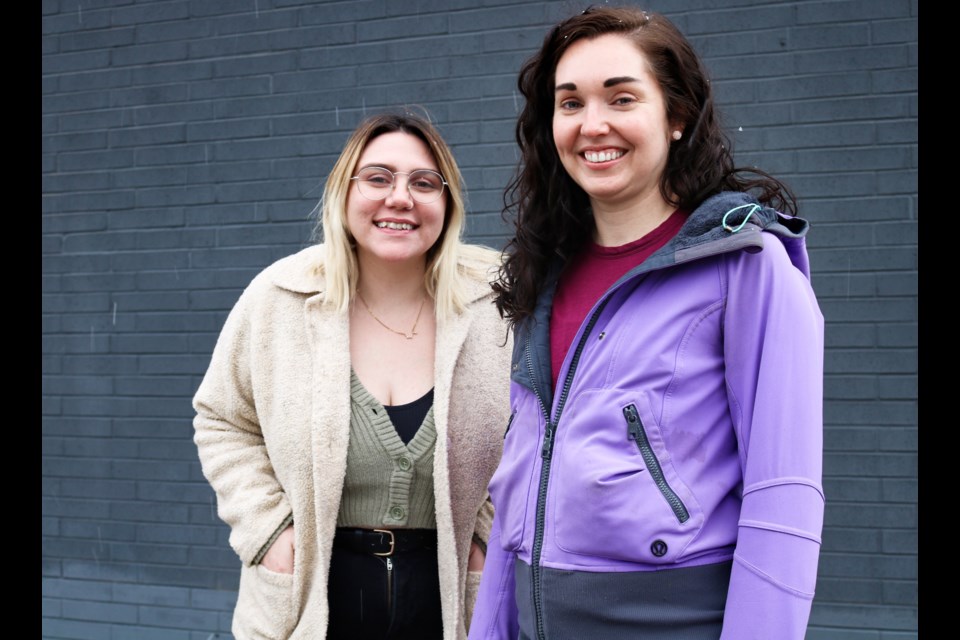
left=320, top=112, right=483, bottom=322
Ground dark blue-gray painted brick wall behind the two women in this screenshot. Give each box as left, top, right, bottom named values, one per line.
left=41, top=0, right=919, bottom=640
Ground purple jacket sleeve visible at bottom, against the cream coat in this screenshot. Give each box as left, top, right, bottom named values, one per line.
left=469, top=515, right=520, bottom=640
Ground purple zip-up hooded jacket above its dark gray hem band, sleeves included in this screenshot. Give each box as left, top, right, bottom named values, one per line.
left=470, top=193, right=824, bottom=640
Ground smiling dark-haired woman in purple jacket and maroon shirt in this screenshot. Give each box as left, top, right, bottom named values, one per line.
left=470, top=7, right=823, bottom=640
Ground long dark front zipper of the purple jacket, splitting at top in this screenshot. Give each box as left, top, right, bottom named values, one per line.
left=527, top=296, right=610, bottom=640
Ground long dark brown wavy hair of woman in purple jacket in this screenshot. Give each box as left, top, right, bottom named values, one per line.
left=493, top=7, right=796, bottom=325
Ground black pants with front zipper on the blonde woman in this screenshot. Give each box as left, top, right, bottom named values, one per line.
left=327, top=536, right=443, bottom=640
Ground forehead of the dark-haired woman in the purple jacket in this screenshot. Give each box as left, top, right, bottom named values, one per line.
left=555, top=33, right=652, bottom=84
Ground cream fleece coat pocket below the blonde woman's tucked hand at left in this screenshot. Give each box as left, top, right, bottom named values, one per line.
left=233, top=564, right=297, bottom=640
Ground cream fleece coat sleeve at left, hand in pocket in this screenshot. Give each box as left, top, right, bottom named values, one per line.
left=193, top=288, right=292, bottom=565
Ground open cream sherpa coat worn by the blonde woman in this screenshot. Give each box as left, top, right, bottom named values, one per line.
left=194, top=246, right=511, bottom=640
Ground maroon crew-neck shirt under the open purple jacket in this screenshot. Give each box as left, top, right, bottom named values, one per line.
left=550, top=209, right=687, bottom=389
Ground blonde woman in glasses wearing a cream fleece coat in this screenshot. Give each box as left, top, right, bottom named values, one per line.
left=194, top=114, right=511, bottom=640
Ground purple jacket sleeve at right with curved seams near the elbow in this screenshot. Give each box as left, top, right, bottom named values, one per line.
left=722, top=234, right=824, bottom=640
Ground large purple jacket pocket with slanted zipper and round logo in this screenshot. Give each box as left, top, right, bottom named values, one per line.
left=551, top=393, right=703, bottom=564
